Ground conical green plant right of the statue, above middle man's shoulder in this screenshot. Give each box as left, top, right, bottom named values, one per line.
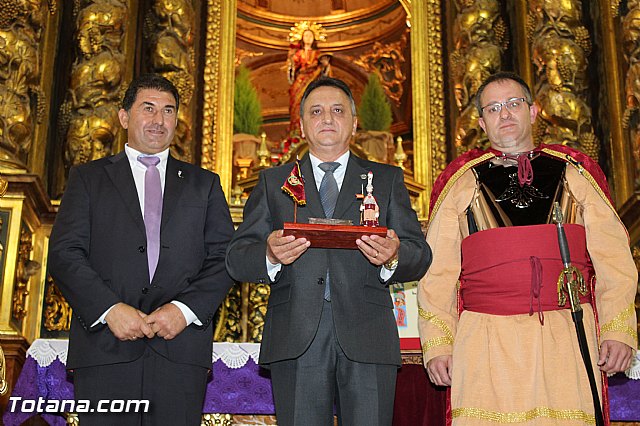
left=358, top=74, right=393, bottom=132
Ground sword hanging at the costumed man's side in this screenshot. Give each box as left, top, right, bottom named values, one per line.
left=553, top=201, right=604, bottom=426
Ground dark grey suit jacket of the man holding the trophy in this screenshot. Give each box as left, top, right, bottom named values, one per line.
left=227, top=154, right=431, bottom=365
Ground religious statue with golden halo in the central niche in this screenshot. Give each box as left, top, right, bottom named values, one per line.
left=287, top=21, right=331, bottom=137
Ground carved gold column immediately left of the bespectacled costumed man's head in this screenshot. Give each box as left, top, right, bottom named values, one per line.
left=450, top=0, right=508, bottom=154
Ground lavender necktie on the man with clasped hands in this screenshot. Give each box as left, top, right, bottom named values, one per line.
left=138, top=155, right=162, bottom=281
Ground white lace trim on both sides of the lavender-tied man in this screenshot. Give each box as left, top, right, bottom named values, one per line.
left=27, top=339, right=260, bottom=368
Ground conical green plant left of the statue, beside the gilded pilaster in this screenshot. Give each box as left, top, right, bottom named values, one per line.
left=233, top=65, right=262, bottom=136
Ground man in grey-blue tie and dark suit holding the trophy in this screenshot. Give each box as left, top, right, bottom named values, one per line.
left=227, top=78, right=431, bottom=426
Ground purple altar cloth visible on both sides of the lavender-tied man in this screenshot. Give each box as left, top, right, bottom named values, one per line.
left=2, top=357, right=275, bottom=426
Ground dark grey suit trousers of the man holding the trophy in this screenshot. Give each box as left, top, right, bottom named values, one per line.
left=270, top=300, right=398, bottom=426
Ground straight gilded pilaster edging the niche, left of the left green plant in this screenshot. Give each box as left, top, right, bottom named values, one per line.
left=201, top=0, right=236, bottom=199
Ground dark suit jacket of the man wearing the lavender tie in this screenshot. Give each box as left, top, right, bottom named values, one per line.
left=49, top=152, right=233, bottom=368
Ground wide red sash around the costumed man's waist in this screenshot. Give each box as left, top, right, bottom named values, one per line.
left=460, top=224, right=595, bottom=321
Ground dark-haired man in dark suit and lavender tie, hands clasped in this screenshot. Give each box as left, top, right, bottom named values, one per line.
left=49, top=74, right=233, bottom=425
